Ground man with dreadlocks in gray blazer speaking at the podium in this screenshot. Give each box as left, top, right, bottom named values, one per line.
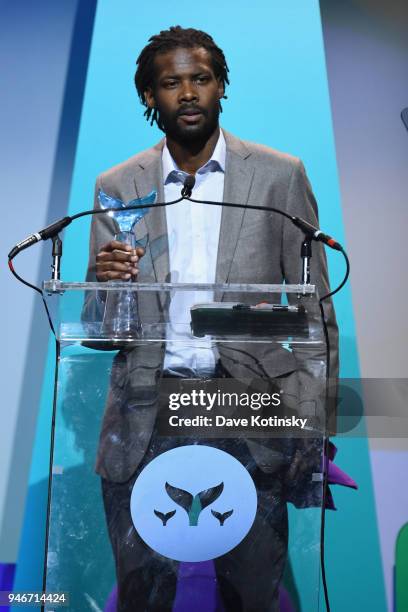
left=87, top=26, right=337, bottom=612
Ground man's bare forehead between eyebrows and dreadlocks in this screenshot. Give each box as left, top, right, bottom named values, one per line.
left=154, top=47, right=212, bottom=76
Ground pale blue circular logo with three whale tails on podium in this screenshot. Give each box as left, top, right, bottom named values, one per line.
left=130, top=445, right=257, bottom=562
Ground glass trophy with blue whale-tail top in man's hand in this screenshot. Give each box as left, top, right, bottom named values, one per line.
left=98, top=189, right=157, bottom=341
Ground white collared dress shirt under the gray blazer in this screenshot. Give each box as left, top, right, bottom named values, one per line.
left=162, top=130, right=226, bottom=376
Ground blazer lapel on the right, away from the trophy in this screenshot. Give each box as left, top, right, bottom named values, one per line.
left=216, top=130, right=255, bottom=283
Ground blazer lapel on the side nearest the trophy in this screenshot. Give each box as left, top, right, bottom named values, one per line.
left=131, top=141, right=170, bottom=282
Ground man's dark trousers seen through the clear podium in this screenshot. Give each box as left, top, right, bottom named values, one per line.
left=102, top=434, right=288, bottom=612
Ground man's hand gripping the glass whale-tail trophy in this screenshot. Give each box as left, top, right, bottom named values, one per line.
left=96, top=240, right=145, bottom=282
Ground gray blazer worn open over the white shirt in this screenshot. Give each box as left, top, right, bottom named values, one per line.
left=87, top=130, right=338, bottom=482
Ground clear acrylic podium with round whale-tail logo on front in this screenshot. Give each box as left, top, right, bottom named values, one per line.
left=43, top=281, right=326, bottom=612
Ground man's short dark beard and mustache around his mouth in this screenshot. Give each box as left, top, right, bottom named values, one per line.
left=158, top=102, right=220, bottom=145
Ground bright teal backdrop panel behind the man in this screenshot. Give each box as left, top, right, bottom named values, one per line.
left=15, top=0, right=385, bottom=611
